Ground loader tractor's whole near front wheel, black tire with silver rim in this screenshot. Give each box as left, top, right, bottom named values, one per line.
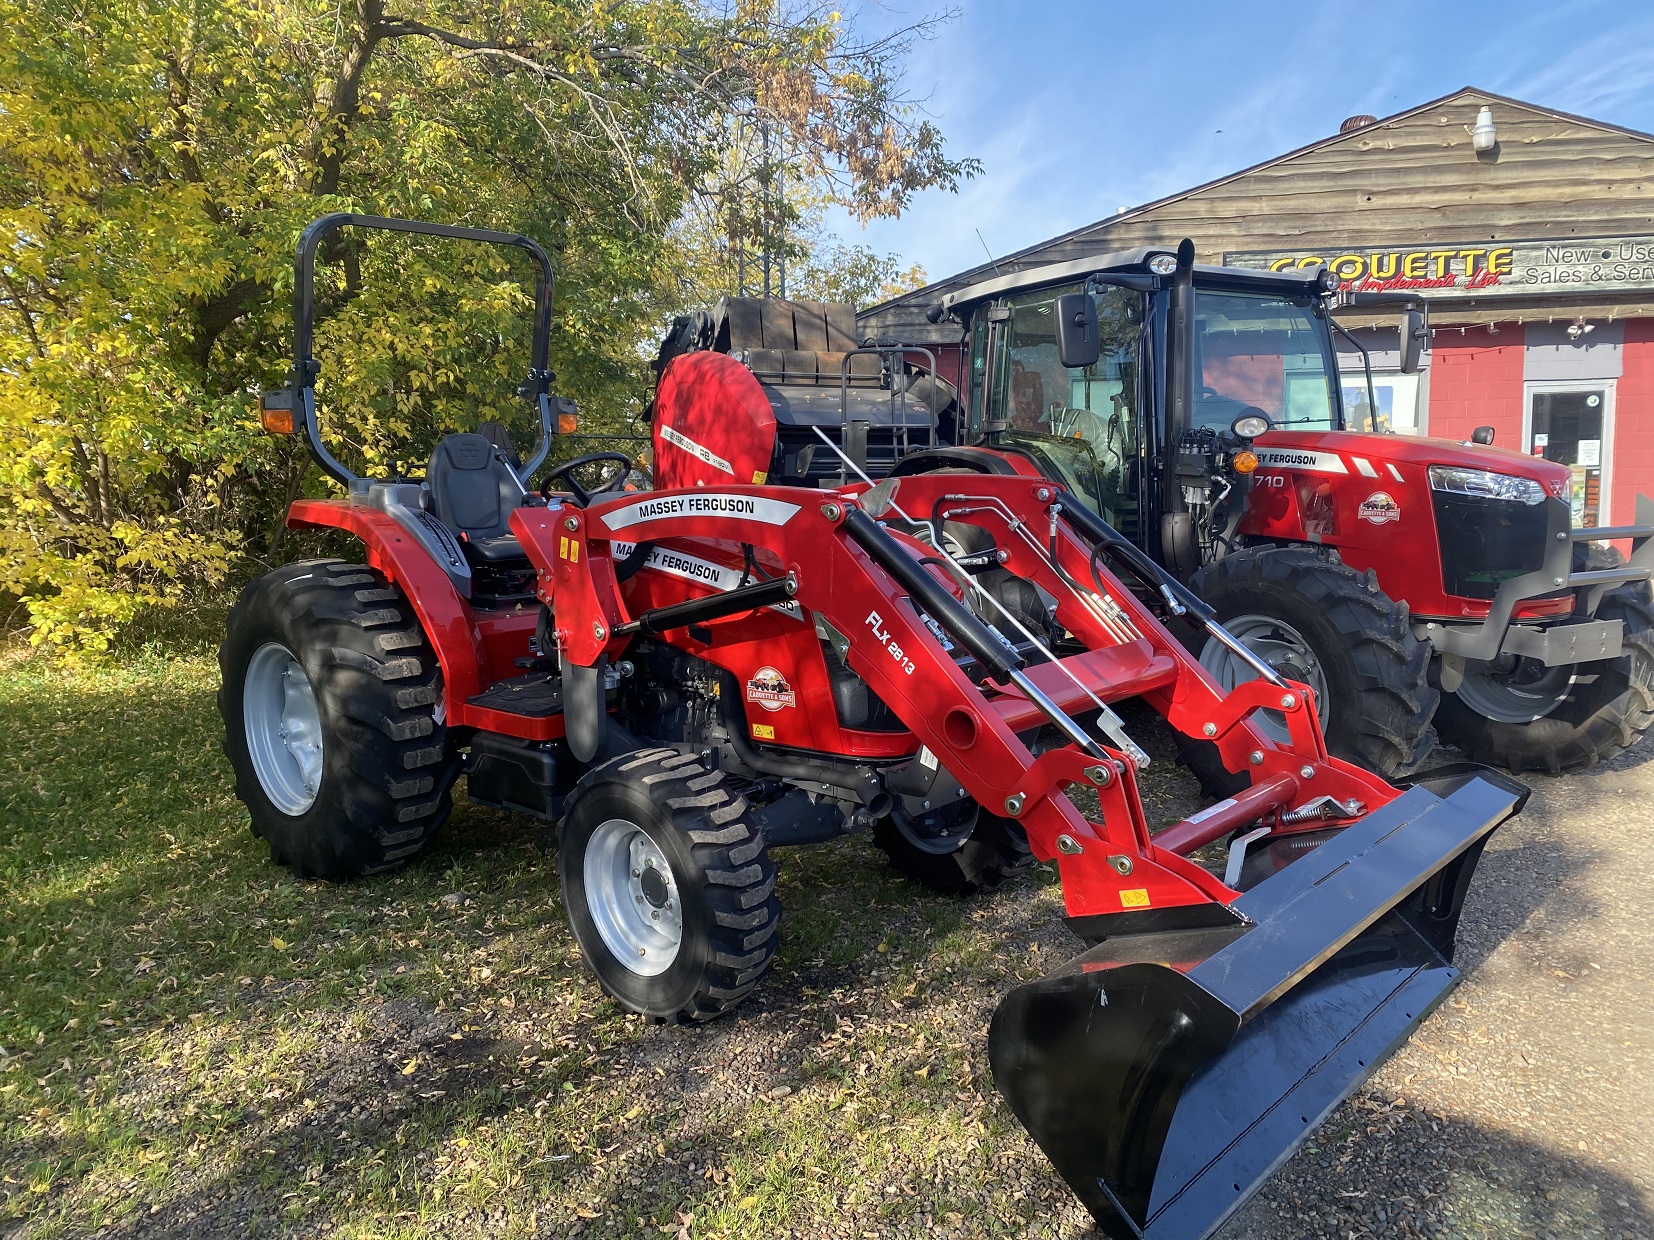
left=557, top=749, right=781, bottom=1023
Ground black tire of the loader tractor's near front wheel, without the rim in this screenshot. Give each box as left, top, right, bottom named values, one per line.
left=557, top=749, right=781, bottom=1023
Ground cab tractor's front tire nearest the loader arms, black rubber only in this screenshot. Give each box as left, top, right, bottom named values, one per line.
left=1178, top=547, right=1441, bottom=797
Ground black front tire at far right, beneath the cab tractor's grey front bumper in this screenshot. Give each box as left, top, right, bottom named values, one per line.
left=1437, top=547, right=1654, bottom=775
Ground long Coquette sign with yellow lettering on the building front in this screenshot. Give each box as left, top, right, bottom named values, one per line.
left=1224, top=236, right=1654, bottom=298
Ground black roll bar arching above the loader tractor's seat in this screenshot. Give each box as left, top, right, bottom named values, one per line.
left=288, top=212, right=556, bottom=486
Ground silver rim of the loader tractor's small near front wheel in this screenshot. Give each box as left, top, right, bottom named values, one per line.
left=584, top=818, right=683, bottom=977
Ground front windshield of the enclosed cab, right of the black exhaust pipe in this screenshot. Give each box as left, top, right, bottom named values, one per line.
left=1191, top=289, right=1338, bottom=430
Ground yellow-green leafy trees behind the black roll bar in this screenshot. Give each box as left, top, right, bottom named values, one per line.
left=0, top=0, right=974, bottom=646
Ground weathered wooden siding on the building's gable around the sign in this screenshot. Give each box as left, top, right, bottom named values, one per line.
left=863, top=91, right=1654, bottom=335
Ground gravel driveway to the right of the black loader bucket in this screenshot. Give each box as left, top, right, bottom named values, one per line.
left=1224, top=742, right=1654, bottom=1240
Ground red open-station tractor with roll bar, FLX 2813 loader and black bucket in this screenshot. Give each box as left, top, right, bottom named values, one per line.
left=220, top=215, right=1525, bottom=1237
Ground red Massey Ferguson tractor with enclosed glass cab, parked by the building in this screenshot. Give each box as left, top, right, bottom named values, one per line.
left=896, top=241, right=1654, bottom=790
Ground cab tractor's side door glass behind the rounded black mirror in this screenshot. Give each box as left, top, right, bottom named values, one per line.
left=978, top=284, right=1143, bottom=529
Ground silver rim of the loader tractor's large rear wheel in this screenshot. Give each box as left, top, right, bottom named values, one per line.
left=241, top=641, right=323, bottom=817
